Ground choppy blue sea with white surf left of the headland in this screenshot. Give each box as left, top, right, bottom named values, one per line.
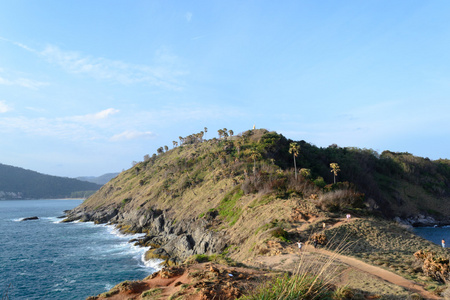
left=0, top=200, right=159, bottom=299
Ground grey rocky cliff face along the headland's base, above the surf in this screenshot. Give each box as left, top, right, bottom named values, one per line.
left=63, top=207, right=228, bottom=265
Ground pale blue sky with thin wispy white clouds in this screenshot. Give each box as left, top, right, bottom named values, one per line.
left=0, top=0, right=450, bottom=177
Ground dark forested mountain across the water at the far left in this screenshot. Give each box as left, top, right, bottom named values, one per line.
left=0, top=164, right=101, bottom=199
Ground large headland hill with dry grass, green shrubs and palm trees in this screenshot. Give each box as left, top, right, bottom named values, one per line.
left=66, top=129, right=450, bottom=298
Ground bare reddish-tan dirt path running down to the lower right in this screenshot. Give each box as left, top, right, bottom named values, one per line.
left=246, top=245, right=442, bottom=299
